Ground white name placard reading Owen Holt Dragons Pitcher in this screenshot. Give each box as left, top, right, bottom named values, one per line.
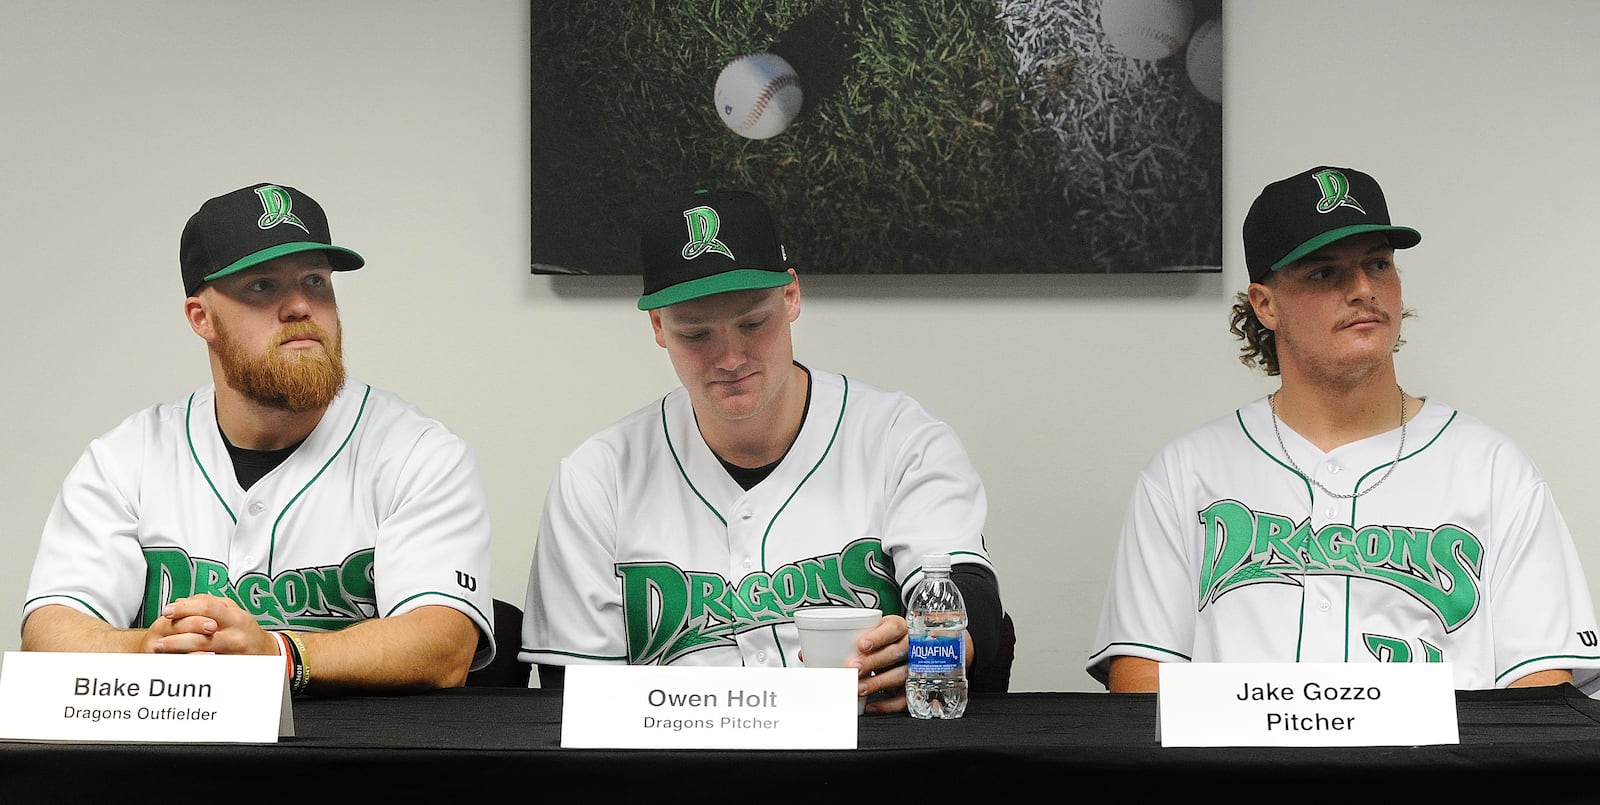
left=562, top=666, right=858, bottom=749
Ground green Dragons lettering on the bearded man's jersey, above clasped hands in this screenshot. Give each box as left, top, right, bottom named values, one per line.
left=139, top=547, right=378, bottom=632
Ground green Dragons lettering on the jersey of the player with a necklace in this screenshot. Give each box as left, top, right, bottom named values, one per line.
left=1200, top=501, right=1483, bottom=632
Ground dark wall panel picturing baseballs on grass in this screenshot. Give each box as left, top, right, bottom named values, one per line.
left=530, top=0, right=1222, bottom=275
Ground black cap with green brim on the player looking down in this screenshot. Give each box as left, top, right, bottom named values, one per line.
left=638, top=190, right=790, bottom=310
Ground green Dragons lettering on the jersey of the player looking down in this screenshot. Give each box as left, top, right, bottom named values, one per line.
left=616, top=539, right=901, bottom=664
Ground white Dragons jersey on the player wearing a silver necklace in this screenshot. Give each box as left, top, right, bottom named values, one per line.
left=1088, top=398, right=1600, bottom=690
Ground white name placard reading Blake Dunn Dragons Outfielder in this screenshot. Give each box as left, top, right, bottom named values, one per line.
left=0, top=651, right=294, bottom=743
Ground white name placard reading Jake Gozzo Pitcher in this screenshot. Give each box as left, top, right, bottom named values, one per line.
left=1155, top=663, right=1461, bottom=746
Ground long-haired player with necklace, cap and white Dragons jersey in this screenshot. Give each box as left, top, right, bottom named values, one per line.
left=1086, top=165, right=1600, bottom=691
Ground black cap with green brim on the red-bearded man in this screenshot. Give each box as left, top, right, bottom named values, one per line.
left=178, top=184, right=366, bottom=296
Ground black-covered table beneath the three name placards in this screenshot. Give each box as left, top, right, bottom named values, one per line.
left=0, top=685, right=1600, bottom=805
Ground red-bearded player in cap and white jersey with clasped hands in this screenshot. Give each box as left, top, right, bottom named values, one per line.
left=22, top=184, right=494, bottom=695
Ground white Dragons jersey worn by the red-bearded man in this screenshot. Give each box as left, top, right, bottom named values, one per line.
left=22, top=381, right=494, bottom=667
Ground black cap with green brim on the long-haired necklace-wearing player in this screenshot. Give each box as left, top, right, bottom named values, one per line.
left=1245, top=165, right=1422, bottom=282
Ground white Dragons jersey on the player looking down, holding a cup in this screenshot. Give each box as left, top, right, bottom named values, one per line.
left=518, top=370, right=992, bottom=667
